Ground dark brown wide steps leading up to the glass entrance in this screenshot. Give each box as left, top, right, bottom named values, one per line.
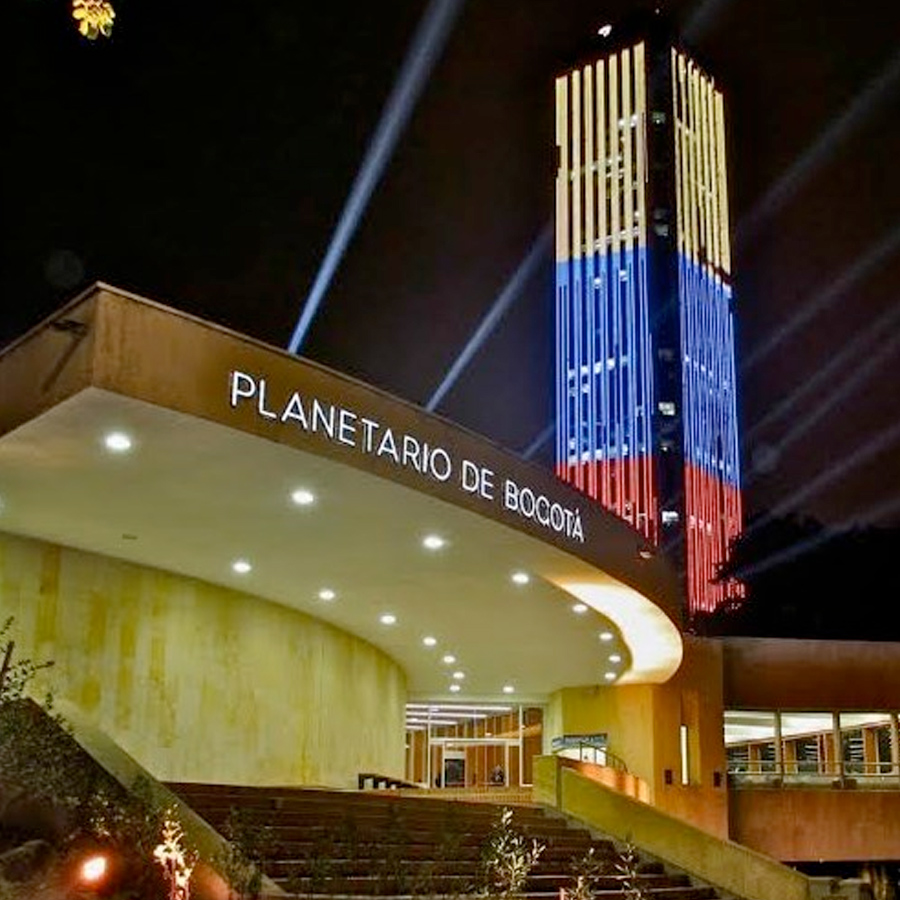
left=169, top=784, right=718, bottom=900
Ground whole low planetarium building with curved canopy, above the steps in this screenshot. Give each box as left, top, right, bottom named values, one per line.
left=0, top=285, right=900, bottom=884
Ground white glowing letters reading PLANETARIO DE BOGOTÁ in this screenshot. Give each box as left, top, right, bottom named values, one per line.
left=228, top=370, right=584, bottom=544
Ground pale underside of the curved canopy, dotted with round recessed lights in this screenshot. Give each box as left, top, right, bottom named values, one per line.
left=0, top=388, right=648, bottom=702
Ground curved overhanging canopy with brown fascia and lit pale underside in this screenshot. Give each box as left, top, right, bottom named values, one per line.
left=0, top=288, right=681, bottom=700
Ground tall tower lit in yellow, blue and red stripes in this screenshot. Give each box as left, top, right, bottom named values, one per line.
left=556, top=26, right=743, bottom=614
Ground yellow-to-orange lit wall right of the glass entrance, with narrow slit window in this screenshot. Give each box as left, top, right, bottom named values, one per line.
left=545, top=636, right=728, bottom=838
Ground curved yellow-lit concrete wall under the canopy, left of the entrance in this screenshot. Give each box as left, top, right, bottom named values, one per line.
left=0, top=533, right=406, bottom=787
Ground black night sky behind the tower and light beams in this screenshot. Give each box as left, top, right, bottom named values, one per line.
left=0, top=0, right=900, bottom=524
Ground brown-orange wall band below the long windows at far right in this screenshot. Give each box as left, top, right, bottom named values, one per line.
left=731, top=788, right=900, bottom=862
